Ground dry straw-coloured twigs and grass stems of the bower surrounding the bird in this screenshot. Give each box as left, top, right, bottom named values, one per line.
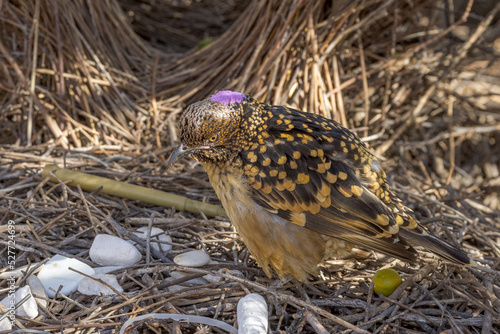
left=0, top=0, right=500, bottom=334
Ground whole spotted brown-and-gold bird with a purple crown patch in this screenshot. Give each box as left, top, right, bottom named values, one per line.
left=169, top=91, right=470, bottom=281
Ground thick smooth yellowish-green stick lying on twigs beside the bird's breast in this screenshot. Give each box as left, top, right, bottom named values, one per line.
left=42, top=165, right=226, bottom=217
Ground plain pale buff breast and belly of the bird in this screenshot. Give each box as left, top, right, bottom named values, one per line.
left=204, top=160, right=325, bottom=281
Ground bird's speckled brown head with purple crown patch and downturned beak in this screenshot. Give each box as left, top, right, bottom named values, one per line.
left=167, top=91, right=262, bottom=168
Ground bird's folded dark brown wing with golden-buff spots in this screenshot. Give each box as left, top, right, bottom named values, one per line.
left=241, top=108, right=416, bottom=262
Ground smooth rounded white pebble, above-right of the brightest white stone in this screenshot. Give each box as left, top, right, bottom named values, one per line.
left=89, top=234, right=142, bottom=267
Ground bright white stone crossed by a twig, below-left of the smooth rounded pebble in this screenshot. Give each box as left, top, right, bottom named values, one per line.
left=37, top=254, right=94, bottom=298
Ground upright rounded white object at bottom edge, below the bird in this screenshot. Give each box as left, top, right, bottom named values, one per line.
left=237, top=293, right=268, bottom=334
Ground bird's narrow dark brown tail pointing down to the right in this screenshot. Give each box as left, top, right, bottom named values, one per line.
left=399, top=228, right=476, bottom=266
